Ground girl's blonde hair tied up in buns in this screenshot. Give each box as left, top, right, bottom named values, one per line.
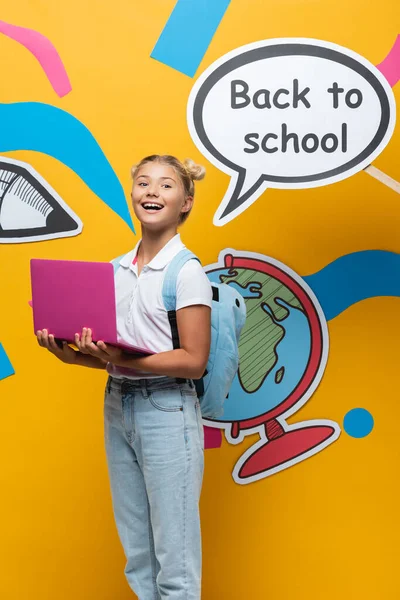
left=131, top=154, right=206, bottom=225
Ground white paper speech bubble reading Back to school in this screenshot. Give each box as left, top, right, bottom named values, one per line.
left=187, top=38, right=396, bottom=225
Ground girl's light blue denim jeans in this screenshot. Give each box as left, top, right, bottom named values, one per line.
left=104, top=377, right=204, bottom=600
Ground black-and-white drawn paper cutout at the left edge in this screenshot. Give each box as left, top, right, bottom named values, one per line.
left=0, top=156, right=82, bottom=244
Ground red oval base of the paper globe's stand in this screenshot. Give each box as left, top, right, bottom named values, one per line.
left=235, top=419, right=337, bottom=481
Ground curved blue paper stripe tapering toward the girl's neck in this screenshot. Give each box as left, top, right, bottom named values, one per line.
left=0, top=102, right=133, bottom=230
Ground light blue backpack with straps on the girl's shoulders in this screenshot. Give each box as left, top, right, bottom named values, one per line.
left=112, top=248, right=246, bottom=419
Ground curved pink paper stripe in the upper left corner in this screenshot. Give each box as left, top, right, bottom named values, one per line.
left=0, top=20, right=72, bottom=98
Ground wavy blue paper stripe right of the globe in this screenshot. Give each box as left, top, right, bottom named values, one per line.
left=303, top=250, right=400, bottom=321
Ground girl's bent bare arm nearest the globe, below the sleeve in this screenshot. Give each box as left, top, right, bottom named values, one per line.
left=118, top=305, right=211, bottom=379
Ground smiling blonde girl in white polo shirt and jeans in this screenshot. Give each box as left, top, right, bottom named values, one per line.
left=37, top=155, right=212, bottom=600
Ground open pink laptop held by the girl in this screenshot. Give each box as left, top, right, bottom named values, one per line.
left=31, top=258, right=153, bottom=354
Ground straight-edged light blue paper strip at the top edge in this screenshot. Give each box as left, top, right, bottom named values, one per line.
left=151, top=0, right=230, bottom=77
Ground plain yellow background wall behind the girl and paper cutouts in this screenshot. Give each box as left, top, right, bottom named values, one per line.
left=0, top=0, right=400, bottom=600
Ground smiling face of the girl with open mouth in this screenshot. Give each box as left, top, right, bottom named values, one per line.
left=132, top=162, right=193, bottom=230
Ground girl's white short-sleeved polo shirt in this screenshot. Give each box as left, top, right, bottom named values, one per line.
left=107, top=234, right=212, bottom=379
